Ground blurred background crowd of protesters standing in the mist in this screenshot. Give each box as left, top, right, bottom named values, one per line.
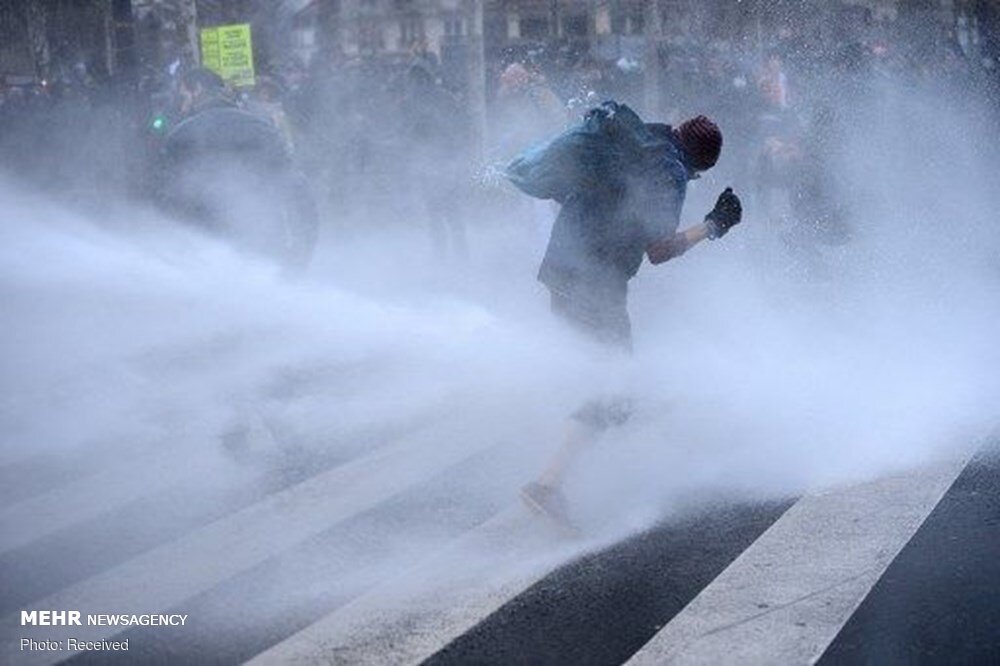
left=0, top=13, right=1000, bottom=256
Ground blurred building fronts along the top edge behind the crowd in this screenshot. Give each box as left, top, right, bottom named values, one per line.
left=0, top=0, right=1000, bottom=85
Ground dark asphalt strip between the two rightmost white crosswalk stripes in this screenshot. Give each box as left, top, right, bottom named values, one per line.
left=425, top=500, right=792, bottom=666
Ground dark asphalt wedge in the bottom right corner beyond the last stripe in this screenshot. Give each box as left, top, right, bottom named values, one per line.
left=819, top=448, right=1000, bottom=666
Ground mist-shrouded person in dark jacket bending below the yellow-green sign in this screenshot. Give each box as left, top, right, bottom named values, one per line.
left=161, top=69, right=318, bottom=267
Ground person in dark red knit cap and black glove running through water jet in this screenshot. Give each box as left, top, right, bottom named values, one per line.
left=508, top=102, right=742, bottom=532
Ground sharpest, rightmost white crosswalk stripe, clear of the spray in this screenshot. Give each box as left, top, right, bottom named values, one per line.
left=628, top=457, right=967, bottom=666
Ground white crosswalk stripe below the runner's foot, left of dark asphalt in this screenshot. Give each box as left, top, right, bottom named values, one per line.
left=247, top=506, right=593, bottom=666
